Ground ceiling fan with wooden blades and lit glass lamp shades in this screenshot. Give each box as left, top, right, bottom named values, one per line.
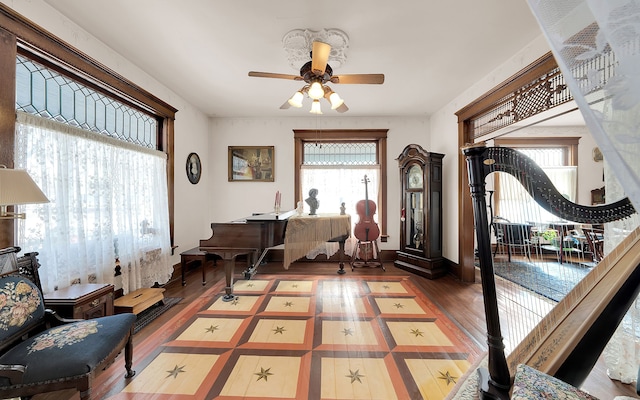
left=249, top=41, right=384, bottom=114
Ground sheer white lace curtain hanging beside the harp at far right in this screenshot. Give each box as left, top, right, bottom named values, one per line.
left=528, top=0, right=640, bottom=382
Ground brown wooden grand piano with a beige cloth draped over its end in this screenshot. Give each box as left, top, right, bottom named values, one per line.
left=199, top=210, right=351, bottom=301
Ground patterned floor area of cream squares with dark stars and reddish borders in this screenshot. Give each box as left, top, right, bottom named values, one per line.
left=93, top=275, right=482, bottom=400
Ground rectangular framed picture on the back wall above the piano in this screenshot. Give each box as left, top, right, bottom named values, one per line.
left=229, top=146, right=275, bottom=182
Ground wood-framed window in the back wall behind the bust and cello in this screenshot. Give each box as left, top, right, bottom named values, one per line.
left=294, top=129, right=387, bottom=241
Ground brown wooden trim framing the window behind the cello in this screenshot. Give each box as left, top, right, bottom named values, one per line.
left=293, top=129, right=389, bottom=242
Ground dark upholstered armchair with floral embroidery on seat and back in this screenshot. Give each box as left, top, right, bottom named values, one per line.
left=0, top=249, right=136, bottom=399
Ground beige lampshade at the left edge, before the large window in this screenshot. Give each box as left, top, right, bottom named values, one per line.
left=0, top=168, right=49, bottom=218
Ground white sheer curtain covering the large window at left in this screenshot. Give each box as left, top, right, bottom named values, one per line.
left=15, top=113, right=172, bottom=293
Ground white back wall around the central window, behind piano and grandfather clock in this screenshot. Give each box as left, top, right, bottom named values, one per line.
left=211, top=116, right=430, bottom=250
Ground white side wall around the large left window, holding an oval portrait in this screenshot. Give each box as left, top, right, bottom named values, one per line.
left=3, top=0, right=211, bottom=264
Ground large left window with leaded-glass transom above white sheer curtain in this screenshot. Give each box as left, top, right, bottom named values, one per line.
left=15, top=57, right=172, bottom=293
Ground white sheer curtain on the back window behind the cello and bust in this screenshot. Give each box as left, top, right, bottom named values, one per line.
left=300, top=166, right=380, bottom=258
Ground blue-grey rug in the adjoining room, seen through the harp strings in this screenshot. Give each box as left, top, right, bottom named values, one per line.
left=493, top=261, right=591, bottom=302
